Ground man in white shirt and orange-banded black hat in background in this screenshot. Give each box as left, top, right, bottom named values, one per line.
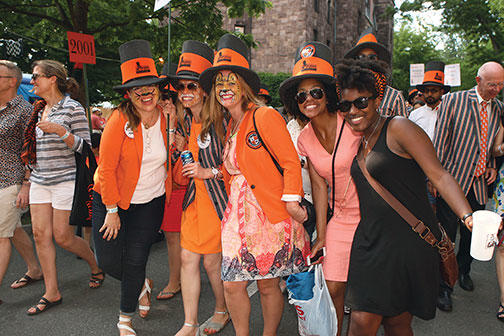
left=408, top=61, right=450, bottom=140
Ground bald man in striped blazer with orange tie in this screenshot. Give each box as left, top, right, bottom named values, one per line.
left=434, top=62, right=504, bottom=311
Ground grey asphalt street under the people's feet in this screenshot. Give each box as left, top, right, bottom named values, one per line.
left=0, top=227, right=504, bottom=336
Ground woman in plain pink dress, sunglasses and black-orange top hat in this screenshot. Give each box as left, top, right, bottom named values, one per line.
left=280, top=42, right=360, bottom=336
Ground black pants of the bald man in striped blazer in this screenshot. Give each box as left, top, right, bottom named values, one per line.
left=436, top=188, right=485, bottom=290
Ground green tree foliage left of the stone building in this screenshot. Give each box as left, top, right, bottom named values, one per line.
left=0, top=0, right=270, bottom=102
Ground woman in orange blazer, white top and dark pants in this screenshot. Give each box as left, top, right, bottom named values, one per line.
left=93, top=40, right=174, bottom=335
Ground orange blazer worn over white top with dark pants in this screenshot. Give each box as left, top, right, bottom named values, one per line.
left=94, top=110, right=172, bottom=210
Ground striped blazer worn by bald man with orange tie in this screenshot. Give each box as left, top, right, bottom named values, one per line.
left=434, top=88, right=504, bottom=204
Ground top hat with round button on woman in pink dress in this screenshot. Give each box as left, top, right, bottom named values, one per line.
left=279, top=41, right=335, bottom=105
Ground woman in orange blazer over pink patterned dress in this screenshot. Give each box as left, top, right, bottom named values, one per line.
left=200, top=34, right=310, bottom=336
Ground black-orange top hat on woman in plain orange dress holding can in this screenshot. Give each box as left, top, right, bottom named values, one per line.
left=168, top=40, right=214, bottom=81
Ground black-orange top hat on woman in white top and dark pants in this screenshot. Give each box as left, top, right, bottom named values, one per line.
left=114, top=40, right=168, bottom=92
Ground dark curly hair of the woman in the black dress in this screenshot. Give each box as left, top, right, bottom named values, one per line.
left=335, top=60, right=387, bottom=97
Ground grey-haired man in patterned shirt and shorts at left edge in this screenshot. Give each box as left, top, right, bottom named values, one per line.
left=0, top=60, right=42, bottom=303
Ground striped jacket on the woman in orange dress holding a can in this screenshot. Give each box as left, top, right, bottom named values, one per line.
left=179, top=113, right=228, bottom=220
